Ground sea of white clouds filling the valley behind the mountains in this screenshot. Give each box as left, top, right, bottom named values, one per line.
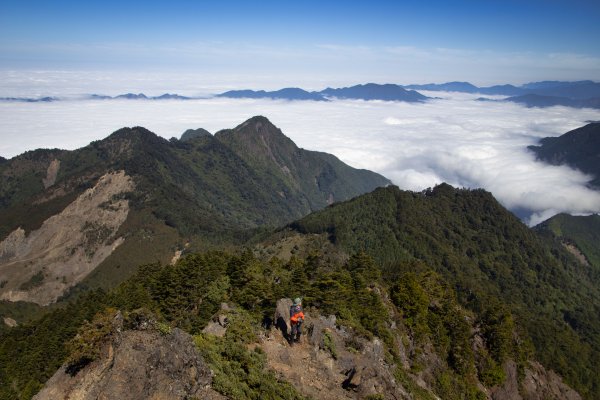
left=0, top=79, right=600, bottom=225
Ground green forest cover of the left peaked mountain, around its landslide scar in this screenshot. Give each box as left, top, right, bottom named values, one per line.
left=0, top=117, right=389, bottom=300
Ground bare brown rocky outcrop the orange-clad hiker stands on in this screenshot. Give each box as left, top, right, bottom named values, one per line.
left=261, top=310, right=411, bottom=400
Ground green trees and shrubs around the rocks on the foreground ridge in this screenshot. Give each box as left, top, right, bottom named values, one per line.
left=0, top=250, right=518, bottom=399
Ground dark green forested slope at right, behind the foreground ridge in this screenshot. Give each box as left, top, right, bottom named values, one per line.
left=290, top=184, right=600, bottom=399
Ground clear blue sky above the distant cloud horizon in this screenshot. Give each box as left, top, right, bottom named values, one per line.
left=0, top=0, right=600, bottom=87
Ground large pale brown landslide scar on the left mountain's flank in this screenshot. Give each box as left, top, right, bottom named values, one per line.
left=0, top=171, right=134, bottom=305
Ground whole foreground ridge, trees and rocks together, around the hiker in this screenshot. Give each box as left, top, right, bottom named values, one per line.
left=0, top=251, right=580, bottom=400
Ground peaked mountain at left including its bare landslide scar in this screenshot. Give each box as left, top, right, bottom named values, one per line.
left=0, top=117, right=389, bottom=304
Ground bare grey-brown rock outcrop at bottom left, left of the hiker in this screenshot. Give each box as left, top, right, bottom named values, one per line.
left=34, top=329, right=224, bottom=400
